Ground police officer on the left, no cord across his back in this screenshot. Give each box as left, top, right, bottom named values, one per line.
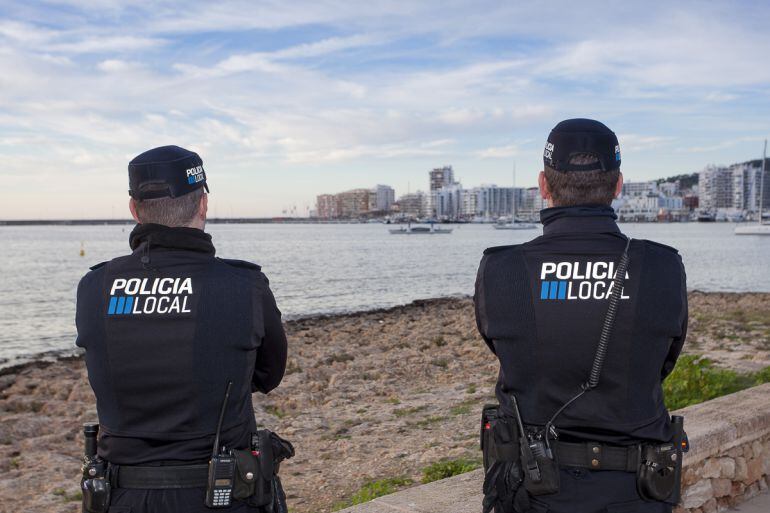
left=76, top=146, right=286, bottom=513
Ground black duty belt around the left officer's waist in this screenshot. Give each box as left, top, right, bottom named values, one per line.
left=108, top=464, right=208, bottom=490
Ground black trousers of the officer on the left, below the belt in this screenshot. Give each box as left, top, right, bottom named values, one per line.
left=109, top=488, right=259, bottom=513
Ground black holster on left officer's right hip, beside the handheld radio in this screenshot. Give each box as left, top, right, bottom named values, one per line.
left=233, top=429, right=294, bottom=513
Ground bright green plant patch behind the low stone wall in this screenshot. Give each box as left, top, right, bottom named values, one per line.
left=663, top=355, right=770, bottom=410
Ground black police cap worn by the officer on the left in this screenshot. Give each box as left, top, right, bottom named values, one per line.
left=128, top=146, right=209, bottom=200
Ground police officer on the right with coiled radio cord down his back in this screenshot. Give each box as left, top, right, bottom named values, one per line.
left=474, top=119, right=687, bottom=513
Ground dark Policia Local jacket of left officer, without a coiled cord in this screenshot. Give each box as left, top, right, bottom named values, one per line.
left=76, top=224, right=286, bottom=465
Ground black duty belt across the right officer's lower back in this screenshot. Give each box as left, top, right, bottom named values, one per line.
left=551, top=440, right=641, bottom=472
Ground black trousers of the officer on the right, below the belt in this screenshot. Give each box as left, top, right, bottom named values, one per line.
left=527, top=467, right=672, bottom=513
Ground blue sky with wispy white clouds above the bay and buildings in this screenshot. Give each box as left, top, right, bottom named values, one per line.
left=0, top=0, right=770, bottom=219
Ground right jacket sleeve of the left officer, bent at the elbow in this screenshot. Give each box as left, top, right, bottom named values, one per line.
left=251, top=278, right=287, bottom=394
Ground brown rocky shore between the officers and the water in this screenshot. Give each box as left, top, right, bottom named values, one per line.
left=0, top=291, right=770, bottom=513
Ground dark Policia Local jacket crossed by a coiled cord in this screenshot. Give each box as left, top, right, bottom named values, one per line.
left=474, top=206, right=687, bottom=445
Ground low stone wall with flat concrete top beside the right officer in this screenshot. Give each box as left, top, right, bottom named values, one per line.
left=343, top=383, right=770, bottom=513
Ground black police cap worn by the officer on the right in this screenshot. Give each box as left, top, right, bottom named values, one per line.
left=543, top=118, right=620, bottom=173
